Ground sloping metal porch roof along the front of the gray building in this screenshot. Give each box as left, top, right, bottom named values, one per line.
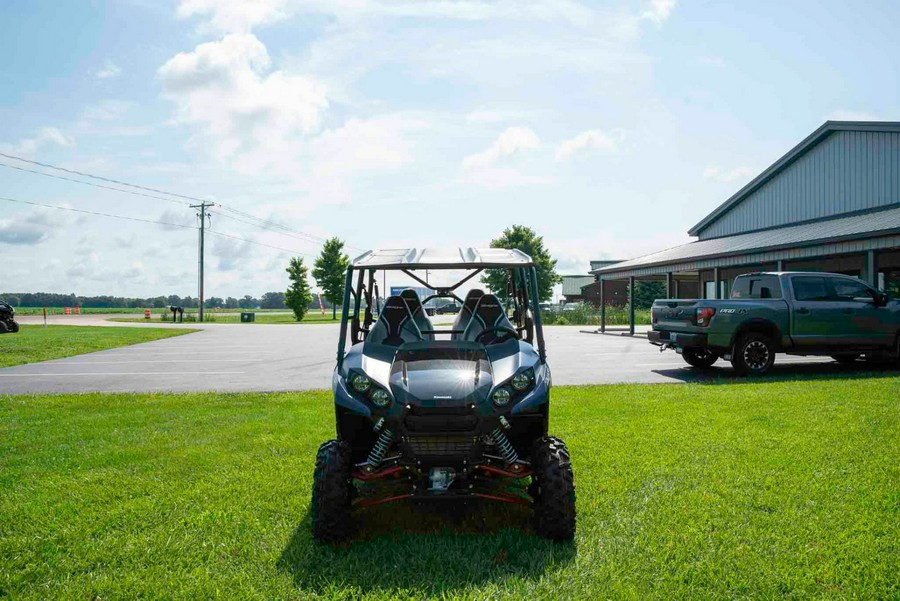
left=591, top=204, right=900, bottom=275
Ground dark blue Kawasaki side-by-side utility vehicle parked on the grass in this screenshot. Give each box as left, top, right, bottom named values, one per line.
left=312, top=248, right=575, bottom=541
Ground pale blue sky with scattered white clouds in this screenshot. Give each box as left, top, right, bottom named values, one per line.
left=0, top=0, right=900, bottom=297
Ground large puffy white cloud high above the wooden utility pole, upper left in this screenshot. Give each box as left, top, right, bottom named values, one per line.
left=158, top=34, right=328, bottom=160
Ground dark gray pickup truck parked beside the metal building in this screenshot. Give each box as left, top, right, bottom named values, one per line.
left=648, top=272, right=900, bottom=374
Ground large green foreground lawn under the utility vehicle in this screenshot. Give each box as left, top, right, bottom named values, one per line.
left=0, top=376, right=900, bottom=599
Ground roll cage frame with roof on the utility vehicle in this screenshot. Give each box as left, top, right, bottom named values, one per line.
left=337, top=248, right=546, bottom=369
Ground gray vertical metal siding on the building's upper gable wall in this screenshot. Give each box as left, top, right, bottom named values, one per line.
left=699, top=131, right=900, bottom=240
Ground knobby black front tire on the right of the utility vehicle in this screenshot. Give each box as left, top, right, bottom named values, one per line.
left=531, top=436, right=575, bottom=541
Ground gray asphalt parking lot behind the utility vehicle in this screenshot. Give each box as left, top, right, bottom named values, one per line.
left=0, top=316, right=884, bottom=394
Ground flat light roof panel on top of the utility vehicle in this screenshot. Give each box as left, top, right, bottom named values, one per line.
left=350, top=247, right=534, bottom=269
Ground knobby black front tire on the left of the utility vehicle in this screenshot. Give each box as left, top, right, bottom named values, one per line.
left=312, top=440, right=353, bottom=542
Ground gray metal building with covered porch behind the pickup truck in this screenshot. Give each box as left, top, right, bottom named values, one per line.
left=591, top=121, right=900, bottom=333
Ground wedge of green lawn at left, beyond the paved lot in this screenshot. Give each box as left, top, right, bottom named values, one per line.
left=0, top=325, right=196, bottom=368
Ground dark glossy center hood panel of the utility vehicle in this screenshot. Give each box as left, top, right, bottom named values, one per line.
left=390, top=342, right=493, bottom=407
